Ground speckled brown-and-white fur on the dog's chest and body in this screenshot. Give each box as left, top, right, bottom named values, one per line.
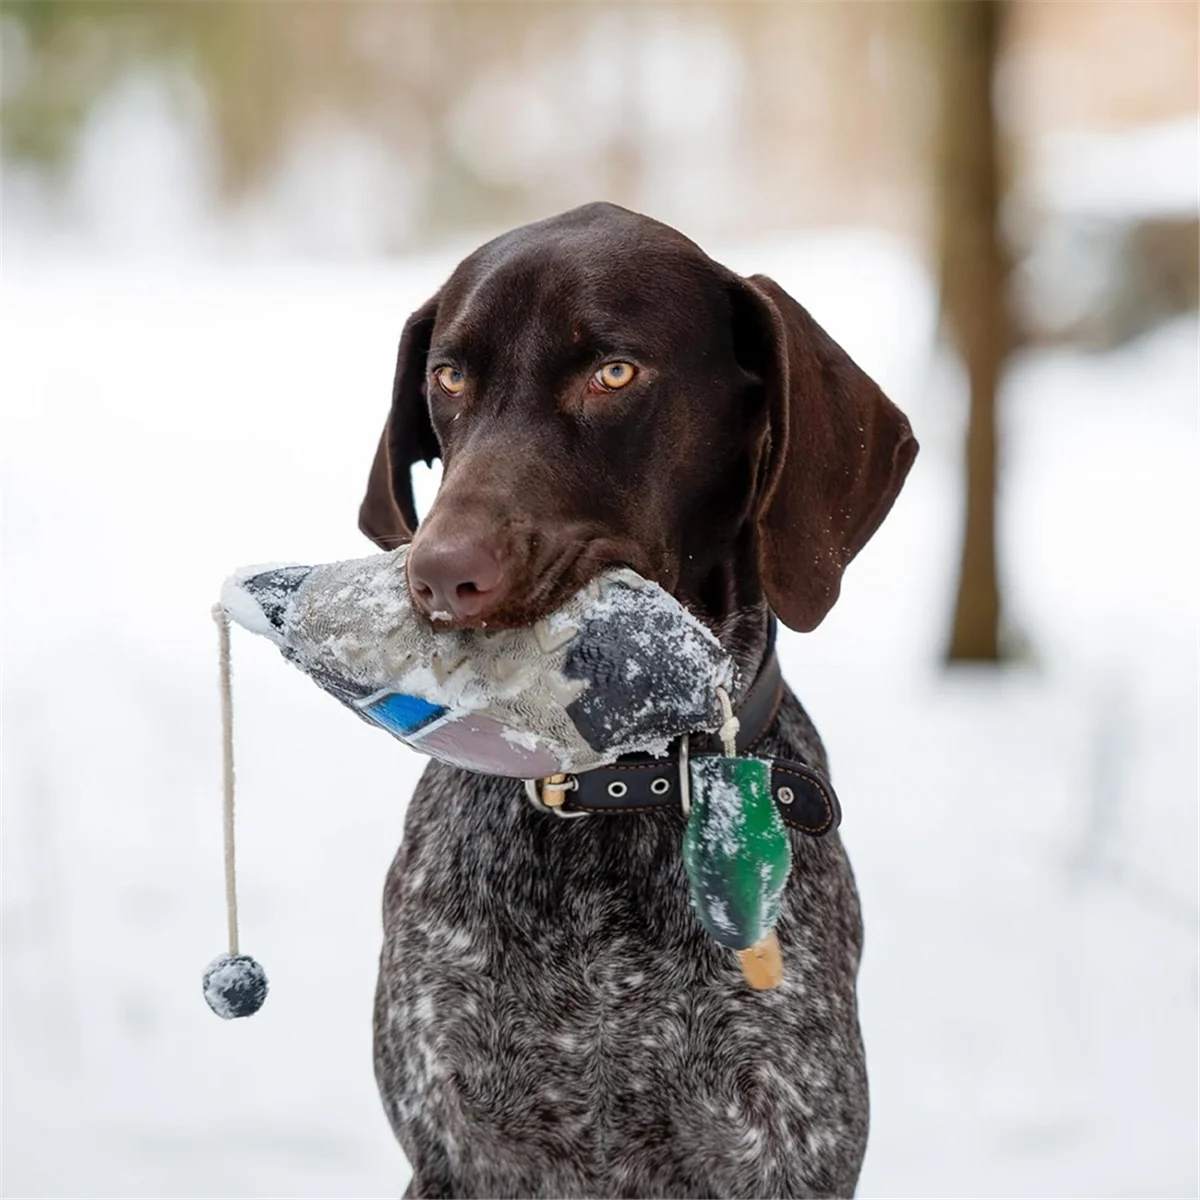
left=376, top=620, right=868, bottom=1200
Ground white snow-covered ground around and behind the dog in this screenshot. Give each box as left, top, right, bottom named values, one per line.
left=0, top=233, right=1200, bottom=1198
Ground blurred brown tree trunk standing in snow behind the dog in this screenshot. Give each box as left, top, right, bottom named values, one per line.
left=934, top=0, right=1012, bottom=662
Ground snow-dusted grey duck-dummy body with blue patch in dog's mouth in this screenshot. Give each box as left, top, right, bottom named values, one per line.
left=221, top=546, right=733, bottom=779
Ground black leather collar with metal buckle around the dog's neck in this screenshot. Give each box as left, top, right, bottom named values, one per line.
left=529, top=618, right=841, bottom=838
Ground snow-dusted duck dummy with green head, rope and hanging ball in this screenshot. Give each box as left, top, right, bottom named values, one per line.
left=204, top=546, right=835, bottom=1018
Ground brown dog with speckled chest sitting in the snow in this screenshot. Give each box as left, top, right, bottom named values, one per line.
left=359, top=204, right=917, bottom=1200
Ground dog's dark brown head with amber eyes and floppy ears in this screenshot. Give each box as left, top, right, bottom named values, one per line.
left=359, top=204, right=917, bottom=630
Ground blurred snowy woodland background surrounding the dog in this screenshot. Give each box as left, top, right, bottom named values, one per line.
left=0, top=0, right=1200, bottom=1198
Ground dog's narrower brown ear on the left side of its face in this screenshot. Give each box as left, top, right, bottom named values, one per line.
left=359, top=296, right=442, bottom=550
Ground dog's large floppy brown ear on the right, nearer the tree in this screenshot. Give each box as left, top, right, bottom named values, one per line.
left=734, top=275, right=917, bottom=631
